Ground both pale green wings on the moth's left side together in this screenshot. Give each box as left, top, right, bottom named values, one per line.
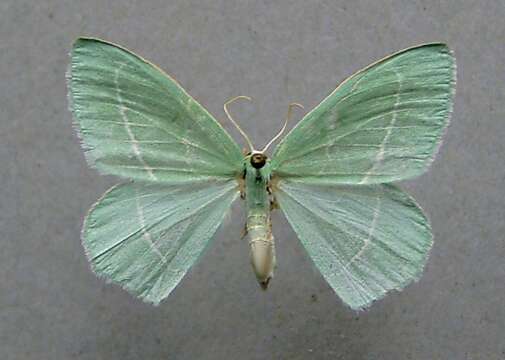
left=68, top=39, right=243, bottom=304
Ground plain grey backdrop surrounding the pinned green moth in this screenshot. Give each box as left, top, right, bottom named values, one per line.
left=0, top=0, right=505, bottom=359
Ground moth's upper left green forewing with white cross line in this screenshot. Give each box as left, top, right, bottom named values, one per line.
left=69, top=38, right=243, bottom=183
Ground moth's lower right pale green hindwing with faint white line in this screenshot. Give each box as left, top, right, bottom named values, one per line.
left=274, top=179, right=432, bottom=309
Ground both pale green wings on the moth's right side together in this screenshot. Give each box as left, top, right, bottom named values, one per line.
left=272, top=44, right=456, bottom=309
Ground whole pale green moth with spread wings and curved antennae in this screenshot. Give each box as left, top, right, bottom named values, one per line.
left=68, top=38, right=456, bottom=309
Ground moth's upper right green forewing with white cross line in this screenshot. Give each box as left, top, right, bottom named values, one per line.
left=272, top=44, right=456, bottom=184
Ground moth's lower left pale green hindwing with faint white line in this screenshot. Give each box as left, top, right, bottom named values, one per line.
left=82, top=180, right=238, bottom=304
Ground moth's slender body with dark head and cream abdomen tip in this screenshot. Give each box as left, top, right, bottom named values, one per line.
left=245, top=153, right=275, bottom=289
